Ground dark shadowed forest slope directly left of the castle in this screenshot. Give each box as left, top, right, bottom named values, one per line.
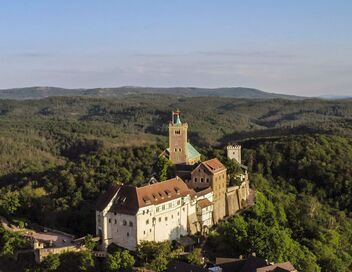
left=0, top=146, right=161, bottom=235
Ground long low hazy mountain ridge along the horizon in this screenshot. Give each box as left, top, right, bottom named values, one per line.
left=0, top=86, right=305, bottom=100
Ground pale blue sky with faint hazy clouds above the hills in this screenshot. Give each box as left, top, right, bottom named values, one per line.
left=0, top=0, right=352, bottom=96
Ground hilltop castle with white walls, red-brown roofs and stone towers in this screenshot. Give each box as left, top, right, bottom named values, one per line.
left=96, top=111, right=250, bottom=250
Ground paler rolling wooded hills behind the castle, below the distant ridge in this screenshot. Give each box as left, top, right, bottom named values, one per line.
left=0, top=94, right=352, bottom=174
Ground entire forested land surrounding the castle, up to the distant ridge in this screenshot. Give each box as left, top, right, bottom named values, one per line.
left=0, top=94, right=352, bottom=272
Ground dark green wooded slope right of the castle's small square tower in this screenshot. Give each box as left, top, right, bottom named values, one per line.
left=245, top=135, right=352, bottom=211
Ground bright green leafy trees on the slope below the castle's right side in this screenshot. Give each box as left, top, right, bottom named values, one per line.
left=211, top=192, right=320, bottom=271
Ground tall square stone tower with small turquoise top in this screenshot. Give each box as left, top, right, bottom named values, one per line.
left=169, top=110, right=188, bottom=164
